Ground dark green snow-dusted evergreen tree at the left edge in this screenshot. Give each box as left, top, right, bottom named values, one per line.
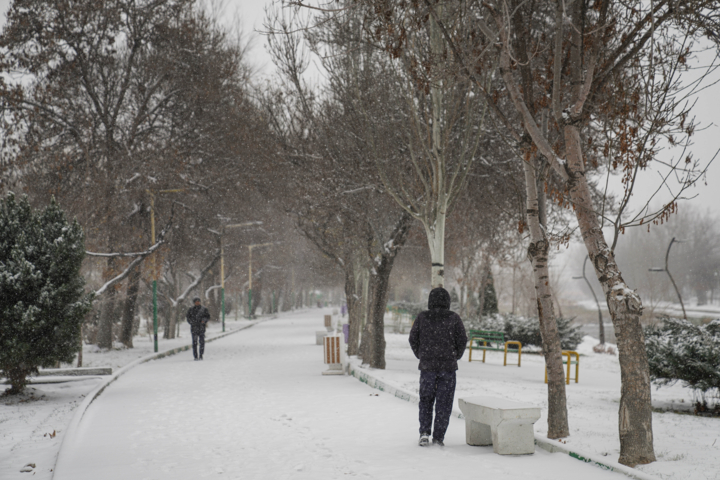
left=0, top=193, right=91, bottom=394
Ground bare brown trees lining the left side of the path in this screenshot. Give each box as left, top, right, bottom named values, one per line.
left=0, top=0, right=336, bottom=348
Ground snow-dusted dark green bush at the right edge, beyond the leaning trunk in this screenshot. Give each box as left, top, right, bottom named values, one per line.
left=645, top=317, right=720, bottom=395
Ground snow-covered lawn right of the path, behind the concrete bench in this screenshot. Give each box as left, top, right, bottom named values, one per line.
left=356, top=334, right=720, bottom=480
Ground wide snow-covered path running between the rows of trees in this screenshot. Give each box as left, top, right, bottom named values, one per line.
left=54, top=310, right=626, bottom=480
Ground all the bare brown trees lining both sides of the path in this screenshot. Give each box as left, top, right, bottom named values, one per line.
left=0, top=0, right=717, bottom=465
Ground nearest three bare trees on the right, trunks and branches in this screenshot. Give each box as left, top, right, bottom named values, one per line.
left=270, top=0, right=718, bottom=465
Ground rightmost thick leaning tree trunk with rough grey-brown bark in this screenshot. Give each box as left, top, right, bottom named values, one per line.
left=564, top=125, right=655, bottom=466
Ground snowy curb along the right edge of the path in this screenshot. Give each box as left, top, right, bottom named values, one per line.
left=348, top=358, right=660, bottom=480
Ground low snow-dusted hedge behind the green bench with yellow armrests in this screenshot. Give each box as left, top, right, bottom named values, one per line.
left=465, top=313, right=583, bottom=350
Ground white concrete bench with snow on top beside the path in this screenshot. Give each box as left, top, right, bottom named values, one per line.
left=458, top=397, right=540, bottom=455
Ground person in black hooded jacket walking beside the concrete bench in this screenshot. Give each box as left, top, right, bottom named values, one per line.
left=410, top=288, right=467, bottom=447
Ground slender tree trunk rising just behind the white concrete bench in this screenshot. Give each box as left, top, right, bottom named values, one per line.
left=523, top=157, right=570, bottom=438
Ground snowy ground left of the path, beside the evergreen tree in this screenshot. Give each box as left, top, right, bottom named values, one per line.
left=0, top=320, right=249, bottom=480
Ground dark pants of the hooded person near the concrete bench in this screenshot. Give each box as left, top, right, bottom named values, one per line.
left=420, top=370, right=455, bottom=440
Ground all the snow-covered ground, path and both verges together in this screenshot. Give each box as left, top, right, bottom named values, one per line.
left=0, top=310, right=720, bottom=480
